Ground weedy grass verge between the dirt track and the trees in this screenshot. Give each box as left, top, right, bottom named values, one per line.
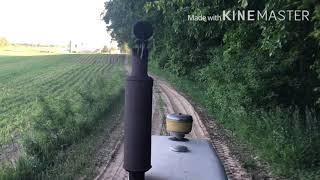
left=149, top=61, right=320, bottom=180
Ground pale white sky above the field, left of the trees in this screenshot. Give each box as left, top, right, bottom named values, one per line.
left=0, top=0, right=116, bottom=49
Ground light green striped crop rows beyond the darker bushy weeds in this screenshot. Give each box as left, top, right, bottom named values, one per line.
left=0, top=54, right=124, bottom=147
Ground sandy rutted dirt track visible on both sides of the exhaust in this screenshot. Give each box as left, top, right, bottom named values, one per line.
left=95, top=77, right=249, bottom=180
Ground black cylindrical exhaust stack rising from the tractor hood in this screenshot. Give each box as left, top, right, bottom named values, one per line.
left=123, top=21, right=153, bottom=180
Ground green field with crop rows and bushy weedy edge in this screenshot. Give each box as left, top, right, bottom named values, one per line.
left=0, top=54, right=126, bottom=178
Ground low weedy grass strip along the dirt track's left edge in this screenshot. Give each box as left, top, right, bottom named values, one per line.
left=0, top=90, right=124, bottom=180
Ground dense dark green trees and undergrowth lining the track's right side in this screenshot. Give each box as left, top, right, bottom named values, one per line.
left=104, top=0, right=320, bottom=175
